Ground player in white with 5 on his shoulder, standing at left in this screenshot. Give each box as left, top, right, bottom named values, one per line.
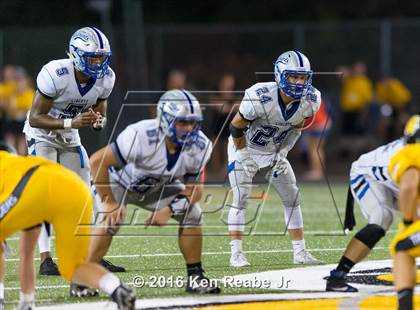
left=23, top=27, right=123, bottom=275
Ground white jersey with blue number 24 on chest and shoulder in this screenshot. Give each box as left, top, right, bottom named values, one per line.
left=228, top=82, right=321, bottom=168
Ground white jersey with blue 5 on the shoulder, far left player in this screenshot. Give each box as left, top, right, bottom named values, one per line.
left=23, top=59, right=115, bottom=146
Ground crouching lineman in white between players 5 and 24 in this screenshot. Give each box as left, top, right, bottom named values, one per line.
left=90, top=90, right=220, bottom=294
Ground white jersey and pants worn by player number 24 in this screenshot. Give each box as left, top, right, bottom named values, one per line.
left=228, top=82, right=321, bottom=232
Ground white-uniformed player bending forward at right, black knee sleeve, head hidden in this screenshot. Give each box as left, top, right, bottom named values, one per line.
left=326, top=138, right=404, bottom=292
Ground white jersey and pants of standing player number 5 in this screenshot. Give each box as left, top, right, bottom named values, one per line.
left=23, top=59, right=115, bottom=186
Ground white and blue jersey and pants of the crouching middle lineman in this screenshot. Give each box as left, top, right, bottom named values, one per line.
left=102, top=119, right=212, bottom=226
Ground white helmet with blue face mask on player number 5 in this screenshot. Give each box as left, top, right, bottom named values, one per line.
left=68, top=27, right=112, bottom=79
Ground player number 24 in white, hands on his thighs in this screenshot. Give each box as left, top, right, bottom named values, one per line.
left=228, top=51, right=321, bottom=267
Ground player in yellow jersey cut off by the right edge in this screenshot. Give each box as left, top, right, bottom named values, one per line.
left=389, top=115, right=420, bottom=310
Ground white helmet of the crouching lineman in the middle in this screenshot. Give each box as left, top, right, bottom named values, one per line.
left=157, top=89, right=203, bottom=145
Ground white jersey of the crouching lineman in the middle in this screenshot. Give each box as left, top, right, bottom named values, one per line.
left=110, top=119, right=212, bottom=193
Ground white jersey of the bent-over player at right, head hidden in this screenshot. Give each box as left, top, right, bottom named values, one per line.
left=350, top=138, right=404, bottom=196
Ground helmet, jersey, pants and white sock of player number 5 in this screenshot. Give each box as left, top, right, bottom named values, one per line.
left=23, top=27, right=115, bottom=262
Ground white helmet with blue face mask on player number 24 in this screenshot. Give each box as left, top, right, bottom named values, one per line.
left=274, top=51, right=312, bottom=99
